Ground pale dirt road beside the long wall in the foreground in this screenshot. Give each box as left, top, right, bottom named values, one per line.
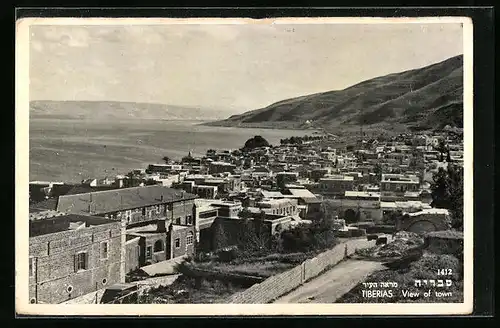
left=274, top=260, right=384, bottom=303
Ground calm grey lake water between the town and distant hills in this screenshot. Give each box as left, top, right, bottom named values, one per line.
left=29, top=119, right=312, bottom=182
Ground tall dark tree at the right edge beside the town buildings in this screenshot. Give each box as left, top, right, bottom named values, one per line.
left=431, top=164, right=464, bottom=230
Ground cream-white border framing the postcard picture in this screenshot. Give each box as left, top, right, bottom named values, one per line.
left=15, top=17, right=474, bottom=316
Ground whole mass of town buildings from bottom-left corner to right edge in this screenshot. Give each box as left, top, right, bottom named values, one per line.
left=26, top=129, right=463, bottom=303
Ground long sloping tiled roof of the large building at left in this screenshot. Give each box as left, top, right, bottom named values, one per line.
left=57, top=185, right=197, bottom=214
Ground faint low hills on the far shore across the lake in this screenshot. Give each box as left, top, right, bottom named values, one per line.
left=30, top=100, right=227, bottom=121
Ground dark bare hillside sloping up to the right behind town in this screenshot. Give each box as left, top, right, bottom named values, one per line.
left=207, top=55, right=463, bottom=130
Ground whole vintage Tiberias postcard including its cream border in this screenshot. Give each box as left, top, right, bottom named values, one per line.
left=16, top=17, right=473, bottom=315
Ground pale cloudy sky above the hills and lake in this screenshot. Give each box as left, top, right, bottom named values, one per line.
left=29, top=23, right=463, bottom=114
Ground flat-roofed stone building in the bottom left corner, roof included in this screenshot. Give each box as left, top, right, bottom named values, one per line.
left=29, top=214, right=125, bottom=304
